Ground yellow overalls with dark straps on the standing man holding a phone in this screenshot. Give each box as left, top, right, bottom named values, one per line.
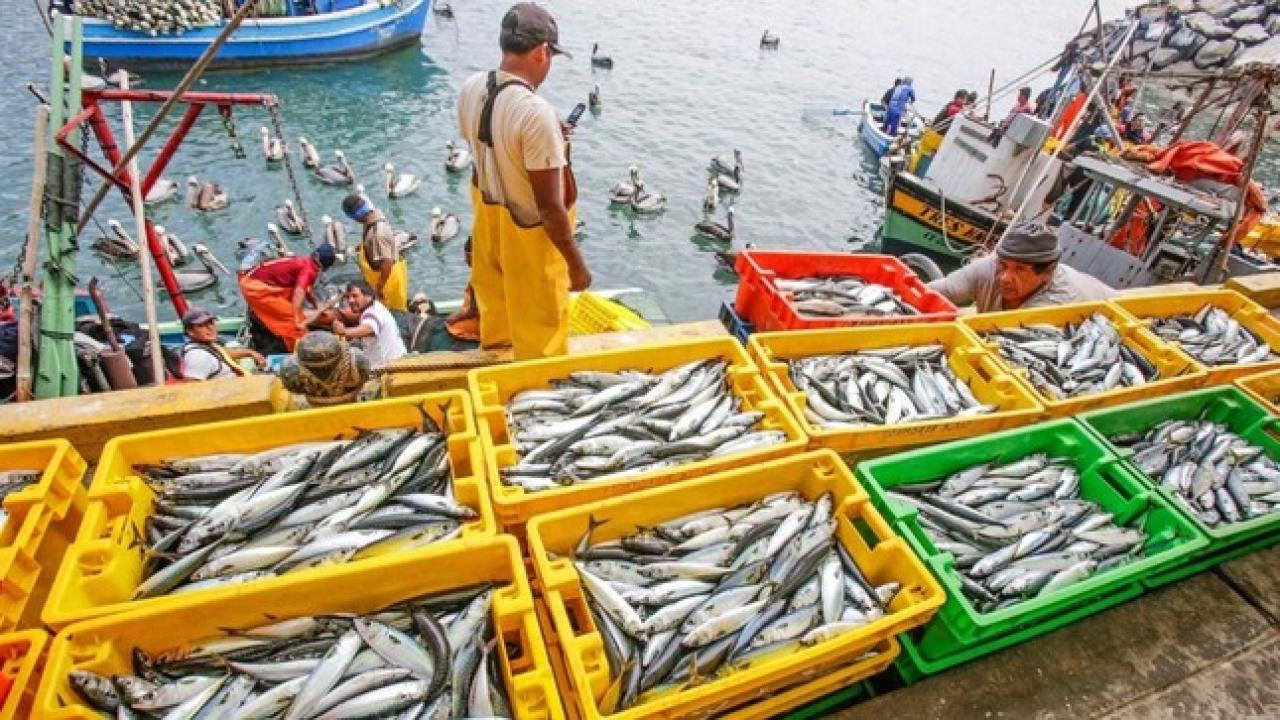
left=471, top=74, right=577, bottom=360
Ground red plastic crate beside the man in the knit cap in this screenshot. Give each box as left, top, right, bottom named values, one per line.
left=735, top=250, right=956, bottom=332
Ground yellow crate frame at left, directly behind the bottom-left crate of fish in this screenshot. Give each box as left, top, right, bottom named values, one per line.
left=44, top=391, right=497, bottom=629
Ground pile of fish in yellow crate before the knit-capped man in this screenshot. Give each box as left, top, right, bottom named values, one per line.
left=986, top=313, right=1160, bottom=400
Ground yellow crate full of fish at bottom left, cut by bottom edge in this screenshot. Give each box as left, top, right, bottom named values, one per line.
left=35, top=537, right=564, bottom=720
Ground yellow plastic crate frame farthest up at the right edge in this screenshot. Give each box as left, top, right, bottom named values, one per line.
left=1111, top=290, right=1280, bottom=386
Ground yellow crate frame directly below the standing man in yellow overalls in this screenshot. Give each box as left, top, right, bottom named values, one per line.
left=467, top=337, right=808, bottom=533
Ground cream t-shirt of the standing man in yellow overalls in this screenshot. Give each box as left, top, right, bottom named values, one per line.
left=458, top=70, right=568, bottom=228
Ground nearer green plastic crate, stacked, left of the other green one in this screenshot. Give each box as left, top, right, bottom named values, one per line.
left=856, top=420, right=1208, bottom=664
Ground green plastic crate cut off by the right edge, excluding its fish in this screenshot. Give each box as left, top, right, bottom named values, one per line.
left=1079, top=386, right=1280, bottom=587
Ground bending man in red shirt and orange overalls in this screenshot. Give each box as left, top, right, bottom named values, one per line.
left=239, top=242, right=335, bottom=352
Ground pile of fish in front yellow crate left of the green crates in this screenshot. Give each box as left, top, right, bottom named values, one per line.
left=573, top=492, right=900, bottom=715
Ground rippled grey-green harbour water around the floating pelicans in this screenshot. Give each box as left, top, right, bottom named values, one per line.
left=0, top=0, right=1274, bottom=319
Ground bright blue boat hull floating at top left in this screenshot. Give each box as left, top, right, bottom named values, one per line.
left=65, top=0, right=431, bottom=69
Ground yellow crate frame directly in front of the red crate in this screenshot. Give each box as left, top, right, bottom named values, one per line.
left=750, top=323, right=1044, bottom=455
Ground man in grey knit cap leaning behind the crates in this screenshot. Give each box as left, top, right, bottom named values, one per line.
left=929, top=223, right=1115, bottom=313
